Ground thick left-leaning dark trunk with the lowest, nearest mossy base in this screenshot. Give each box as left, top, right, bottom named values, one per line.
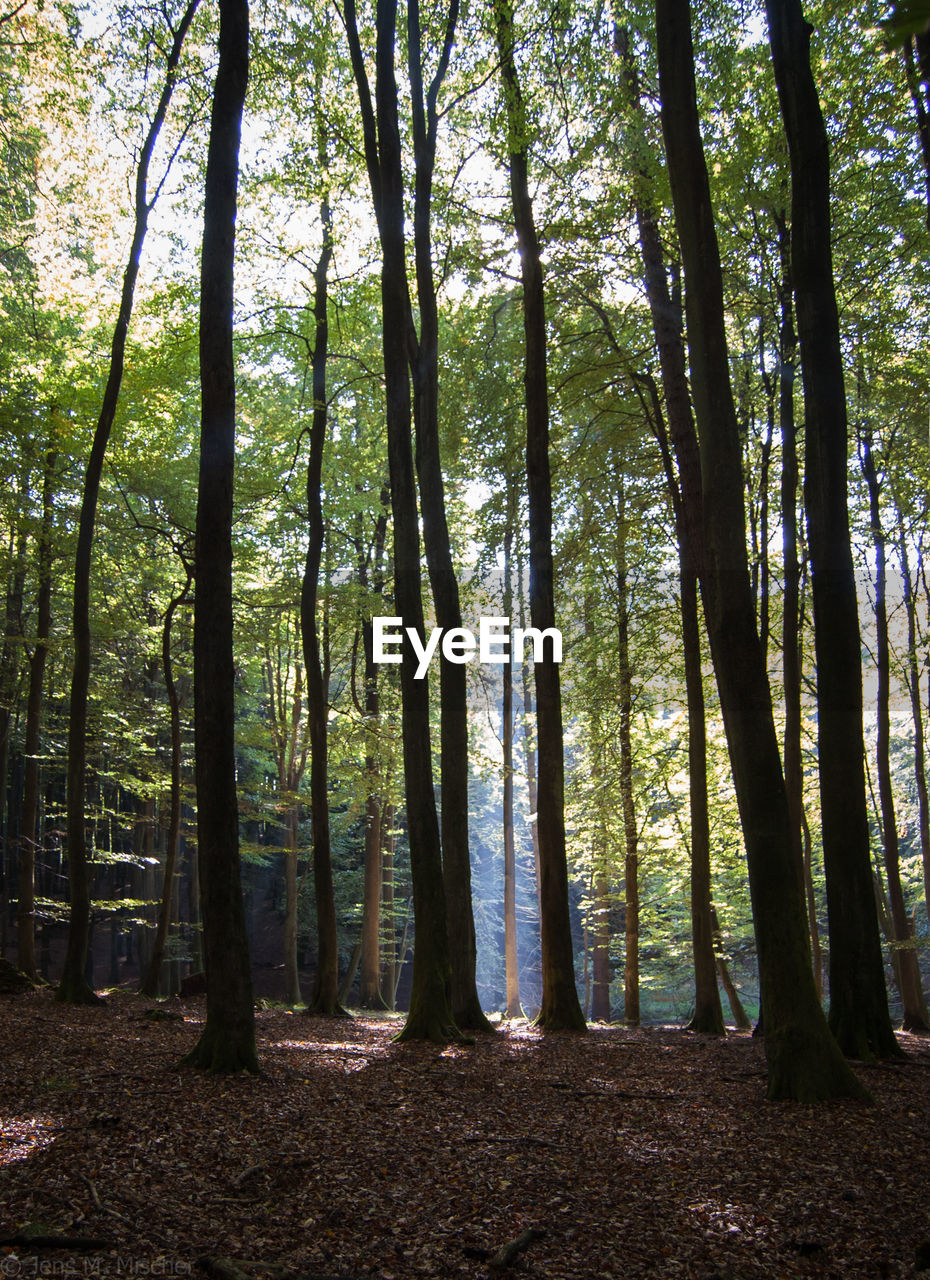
left=656, top=0, right=865, bottom=1100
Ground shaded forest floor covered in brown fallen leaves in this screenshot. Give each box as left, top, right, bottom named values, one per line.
left=0, top=991, right=930, bottom=1280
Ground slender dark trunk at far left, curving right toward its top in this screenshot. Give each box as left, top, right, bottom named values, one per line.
left=56, top=0, right=200, bottom=1004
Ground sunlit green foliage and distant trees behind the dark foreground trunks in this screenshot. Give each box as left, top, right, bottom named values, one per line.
left=0, top=3, right=930, bottom=1059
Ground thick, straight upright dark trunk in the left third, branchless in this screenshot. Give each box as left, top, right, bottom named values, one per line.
left=184, top=0, right=258, bottom=1071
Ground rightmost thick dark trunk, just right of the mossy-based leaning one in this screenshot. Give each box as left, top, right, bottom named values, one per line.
left=766, top=0, right=901, bottom=1057
